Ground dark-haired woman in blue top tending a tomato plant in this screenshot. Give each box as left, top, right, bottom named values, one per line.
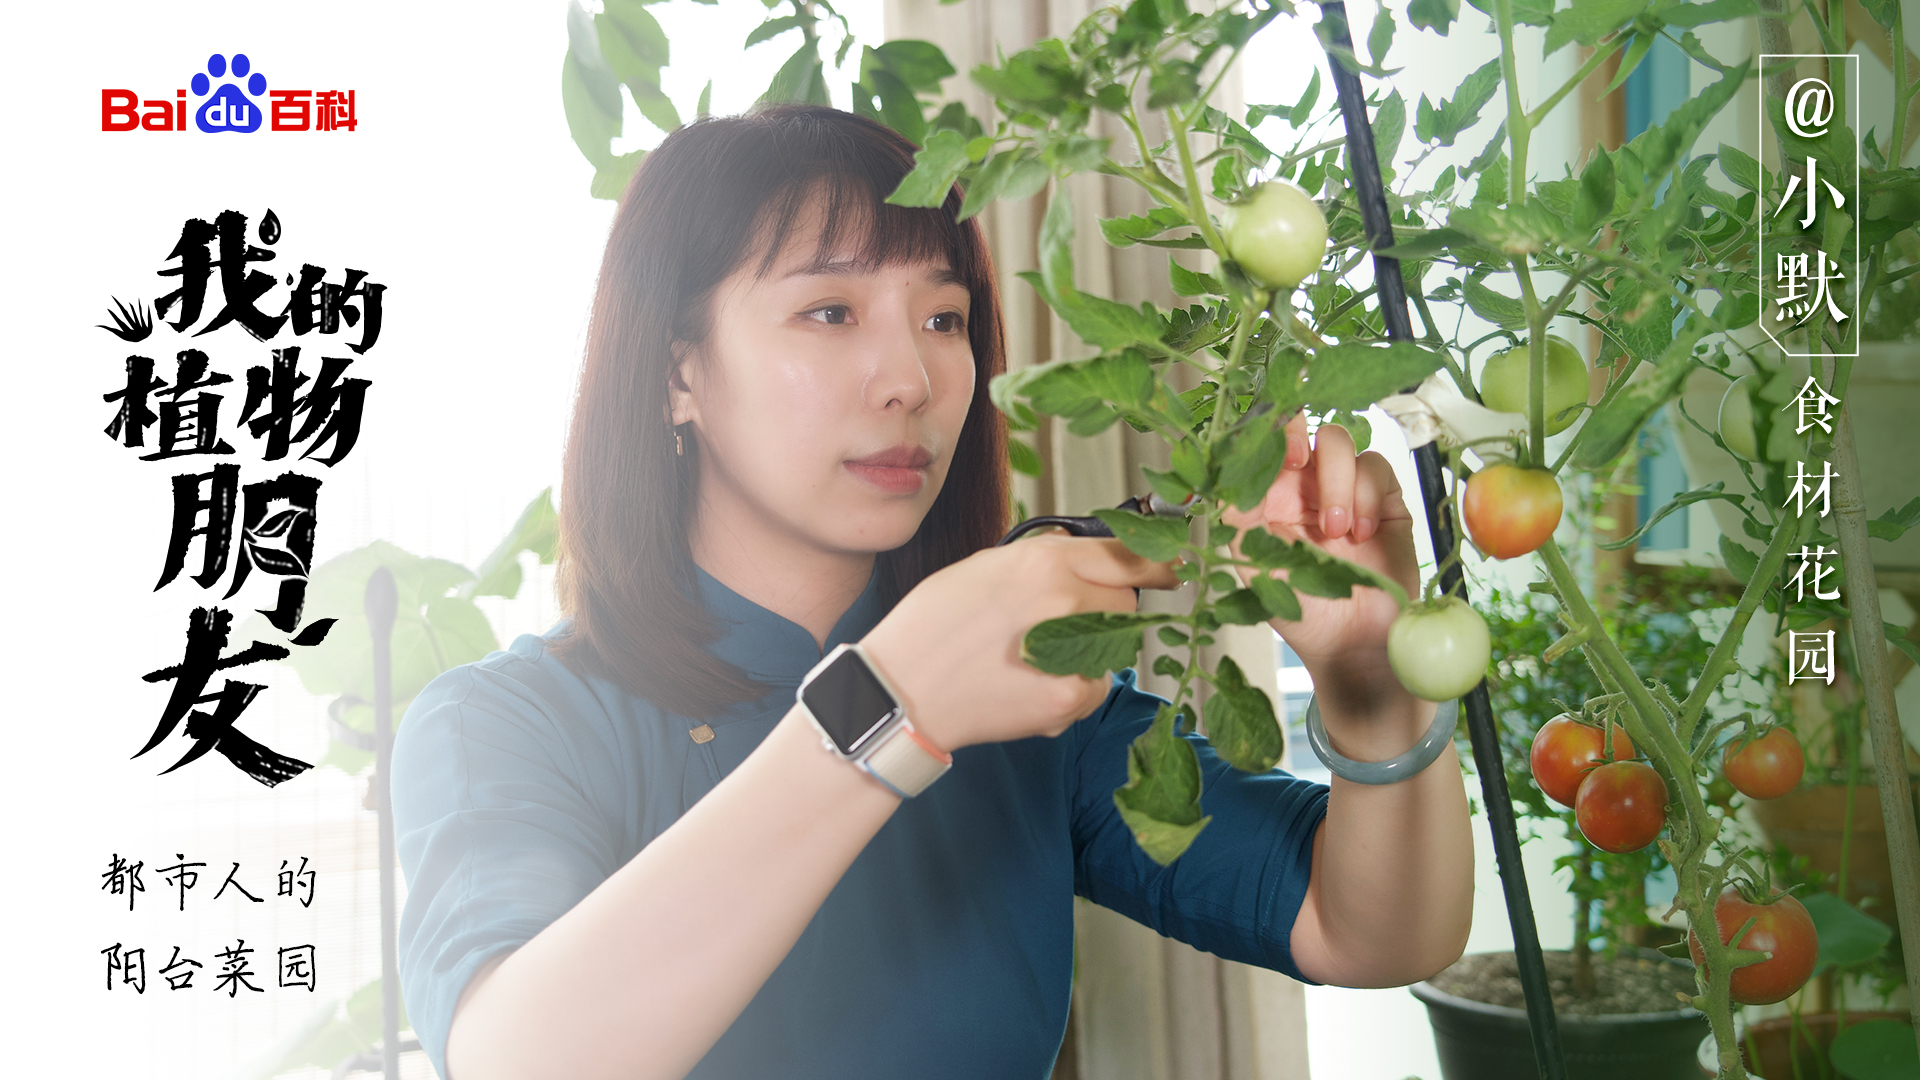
left=394, top=106, right=1473, bottom=1080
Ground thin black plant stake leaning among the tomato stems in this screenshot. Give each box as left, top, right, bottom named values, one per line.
left=1321, top=4, right=1567, bottom=1080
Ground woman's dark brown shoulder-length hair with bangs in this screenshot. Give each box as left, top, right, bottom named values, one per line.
left=553, top=106, right=1008, bottom=719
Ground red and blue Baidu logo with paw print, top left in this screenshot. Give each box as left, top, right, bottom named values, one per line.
left=100, top=52, right=359, bottom=135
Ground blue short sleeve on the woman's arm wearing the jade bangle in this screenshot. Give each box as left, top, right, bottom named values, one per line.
left=1069, top=669, right=1327, bottom=984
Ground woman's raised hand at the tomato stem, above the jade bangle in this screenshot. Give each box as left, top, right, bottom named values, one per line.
left=1225, top=407, right=1419, bottom=707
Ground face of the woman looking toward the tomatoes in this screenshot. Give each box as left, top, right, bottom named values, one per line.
left=670, top=202, right=973, bottom=555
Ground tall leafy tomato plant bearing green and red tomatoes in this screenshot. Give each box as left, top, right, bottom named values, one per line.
left=852, top=0, right=1920, bottom=1060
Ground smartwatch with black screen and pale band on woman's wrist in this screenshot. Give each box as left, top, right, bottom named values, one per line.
left=795, top=642, right=954, bottom=799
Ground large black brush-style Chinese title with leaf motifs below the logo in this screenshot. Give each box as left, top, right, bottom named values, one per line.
left=102, top=209, right=386, bottom=786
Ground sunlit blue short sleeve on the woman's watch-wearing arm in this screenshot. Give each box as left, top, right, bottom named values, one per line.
left=392, top=653, right=618, bottom=1076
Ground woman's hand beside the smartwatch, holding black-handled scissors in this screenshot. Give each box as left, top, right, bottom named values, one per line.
left=860, top=534, right=1179, bottom=751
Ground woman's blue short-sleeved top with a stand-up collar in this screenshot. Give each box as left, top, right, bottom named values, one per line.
left=394, top=571, right=1327, bottom=1080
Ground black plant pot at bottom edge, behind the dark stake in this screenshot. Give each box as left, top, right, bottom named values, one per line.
left=1409, top=949, right=1709, bottom=1080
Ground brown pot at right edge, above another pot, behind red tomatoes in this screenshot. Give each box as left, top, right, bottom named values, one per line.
left=1747, top=784, right=1920, bottom=926
